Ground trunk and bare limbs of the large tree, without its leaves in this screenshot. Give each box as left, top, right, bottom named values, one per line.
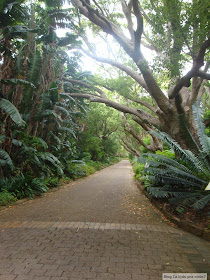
left=68, top=0, right=210, bottom=152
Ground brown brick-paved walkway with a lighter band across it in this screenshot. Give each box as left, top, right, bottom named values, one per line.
left=0, top=160, right=210, bottom=280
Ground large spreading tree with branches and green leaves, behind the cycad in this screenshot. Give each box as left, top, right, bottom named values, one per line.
left=65, top=0, right=210, bottom=151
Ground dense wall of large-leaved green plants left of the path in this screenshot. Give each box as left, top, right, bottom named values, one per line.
left=0, top=0, right=120, bottom=204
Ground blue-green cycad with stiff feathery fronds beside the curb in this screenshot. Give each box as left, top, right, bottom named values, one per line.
left=138, top=102, right=210, bottom=212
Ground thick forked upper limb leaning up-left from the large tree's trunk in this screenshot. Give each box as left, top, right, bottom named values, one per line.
left=73, top=0, right=171, bottom=113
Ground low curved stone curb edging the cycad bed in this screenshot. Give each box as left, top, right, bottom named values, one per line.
left=136, top=181, right=210, bottom=241
